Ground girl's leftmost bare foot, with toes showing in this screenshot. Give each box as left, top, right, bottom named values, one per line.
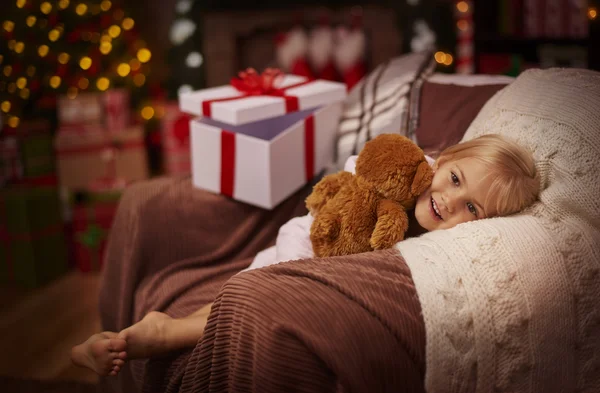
left=71, top=332, right=127, bottom=376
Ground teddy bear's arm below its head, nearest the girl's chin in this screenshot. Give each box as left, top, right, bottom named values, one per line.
left=370, top=199, right=408, bottom=250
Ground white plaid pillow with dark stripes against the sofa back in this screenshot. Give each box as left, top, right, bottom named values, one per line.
left=335, top=52, right=435, bottom=170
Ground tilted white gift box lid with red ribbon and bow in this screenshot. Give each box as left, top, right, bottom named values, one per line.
left=179, top=69, right=346, bottom=125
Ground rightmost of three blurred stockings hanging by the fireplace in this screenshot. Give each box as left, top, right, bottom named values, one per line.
left=334, top=26, right=367, bottom=90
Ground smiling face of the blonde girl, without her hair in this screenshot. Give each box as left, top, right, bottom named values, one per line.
left=415, top=158, right=493, bottom=231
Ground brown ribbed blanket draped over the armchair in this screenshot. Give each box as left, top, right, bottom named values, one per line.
left=100, top=179, right=425, bottom=393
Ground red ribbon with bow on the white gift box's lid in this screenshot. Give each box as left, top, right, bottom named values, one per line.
left=202, top=68, right=312, bottom=117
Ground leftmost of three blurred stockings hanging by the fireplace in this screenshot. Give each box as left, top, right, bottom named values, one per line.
left=276, top=27, right=315, bottom=80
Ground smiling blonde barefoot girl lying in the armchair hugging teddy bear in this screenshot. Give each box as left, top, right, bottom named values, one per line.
left=71, top=135, right=540, bottom=375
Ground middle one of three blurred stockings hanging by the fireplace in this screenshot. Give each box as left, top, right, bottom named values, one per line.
left=308, top=19, right=339, bottom=81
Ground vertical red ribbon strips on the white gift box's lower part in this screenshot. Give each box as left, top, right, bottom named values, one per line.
left=221, top=115, right=315, bottom=198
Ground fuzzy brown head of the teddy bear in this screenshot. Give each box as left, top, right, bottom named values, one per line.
left=356, top=134, right=433, bottom=207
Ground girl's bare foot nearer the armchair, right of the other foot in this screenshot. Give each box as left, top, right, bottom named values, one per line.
left=118, top=311, right=172, bottom=359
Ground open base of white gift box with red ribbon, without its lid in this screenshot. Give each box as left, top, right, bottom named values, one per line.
left=190, top=102, right=342, bottom=209
